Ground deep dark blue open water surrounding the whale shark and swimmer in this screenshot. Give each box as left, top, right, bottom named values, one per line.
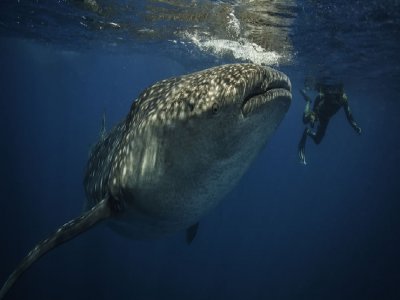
left=0, top=1, right=400, bottom=300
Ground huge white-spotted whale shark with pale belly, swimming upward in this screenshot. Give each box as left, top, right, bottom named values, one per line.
left=0, top=63, right=292, bottom=299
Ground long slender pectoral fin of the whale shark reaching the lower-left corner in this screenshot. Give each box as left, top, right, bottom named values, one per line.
left=0, top=199, right=111, bottom=300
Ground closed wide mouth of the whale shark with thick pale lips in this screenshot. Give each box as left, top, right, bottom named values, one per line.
left=241, top=71, right=292, bottom=117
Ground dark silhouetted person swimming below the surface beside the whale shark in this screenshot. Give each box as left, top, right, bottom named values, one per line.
left=298, top=83, right=361, bottom=165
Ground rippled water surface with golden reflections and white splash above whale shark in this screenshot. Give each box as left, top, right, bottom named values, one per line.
left=0, top=0, right=400, bottom=85
